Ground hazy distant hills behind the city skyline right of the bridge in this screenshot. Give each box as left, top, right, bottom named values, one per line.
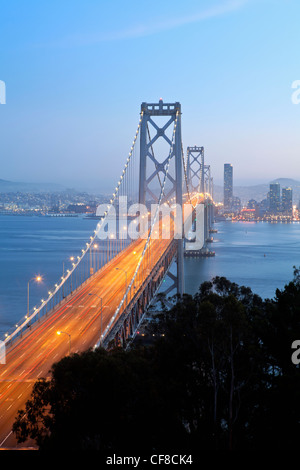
left=214, top=178, right=300, bottom=204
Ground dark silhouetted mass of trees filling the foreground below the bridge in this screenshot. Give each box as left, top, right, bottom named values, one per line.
left=13, top=268, right=300, bottom=453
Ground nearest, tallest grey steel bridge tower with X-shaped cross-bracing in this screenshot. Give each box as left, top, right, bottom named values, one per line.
left=139, top=99, right=184, bottom=295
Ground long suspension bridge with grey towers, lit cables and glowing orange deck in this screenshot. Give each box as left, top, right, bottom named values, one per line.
left=0, top=99, right=213, bottom=448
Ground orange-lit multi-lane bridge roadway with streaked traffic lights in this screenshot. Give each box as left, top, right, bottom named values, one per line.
left=0, top=194, right=204, bottom=449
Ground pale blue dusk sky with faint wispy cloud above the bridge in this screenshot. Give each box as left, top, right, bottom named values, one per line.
left=0, top=0, right=300, bottom=191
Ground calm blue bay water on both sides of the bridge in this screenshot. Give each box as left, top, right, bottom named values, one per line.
left=0, top=215, right=300, bottom=339
